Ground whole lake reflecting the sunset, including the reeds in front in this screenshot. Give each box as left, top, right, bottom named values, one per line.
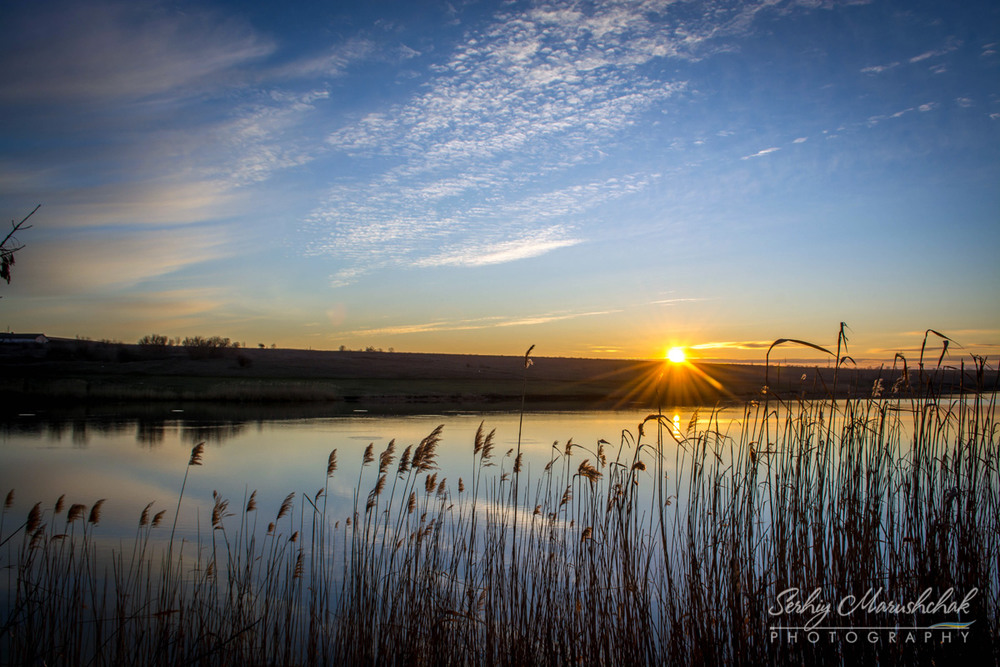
left=0, top=395, right=1000, bottom=664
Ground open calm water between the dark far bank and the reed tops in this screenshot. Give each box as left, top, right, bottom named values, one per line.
left=0, top=407, right=743, bottom=538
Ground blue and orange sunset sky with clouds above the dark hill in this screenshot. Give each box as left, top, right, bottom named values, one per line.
left=0, top=0, right=1000, bottom=363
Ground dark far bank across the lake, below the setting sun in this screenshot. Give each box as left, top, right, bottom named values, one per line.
left=0, top=339, right=997, bottom=409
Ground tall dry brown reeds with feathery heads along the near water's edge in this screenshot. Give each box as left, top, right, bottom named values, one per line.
left=0, top=352, right=1000, bottom=665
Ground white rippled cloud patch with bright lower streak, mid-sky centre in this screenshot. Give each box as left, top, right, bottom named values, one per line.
left=310, top=170, right=659, bottom=287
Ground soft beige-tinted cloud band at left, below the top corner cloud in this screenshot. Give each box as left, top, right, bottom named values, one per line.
left=0, top=85, right=325, bottom=237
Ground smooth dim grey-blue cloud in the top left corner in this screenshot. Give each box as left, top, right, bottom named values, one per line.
left=0, top=1, right=275, bottom=103
